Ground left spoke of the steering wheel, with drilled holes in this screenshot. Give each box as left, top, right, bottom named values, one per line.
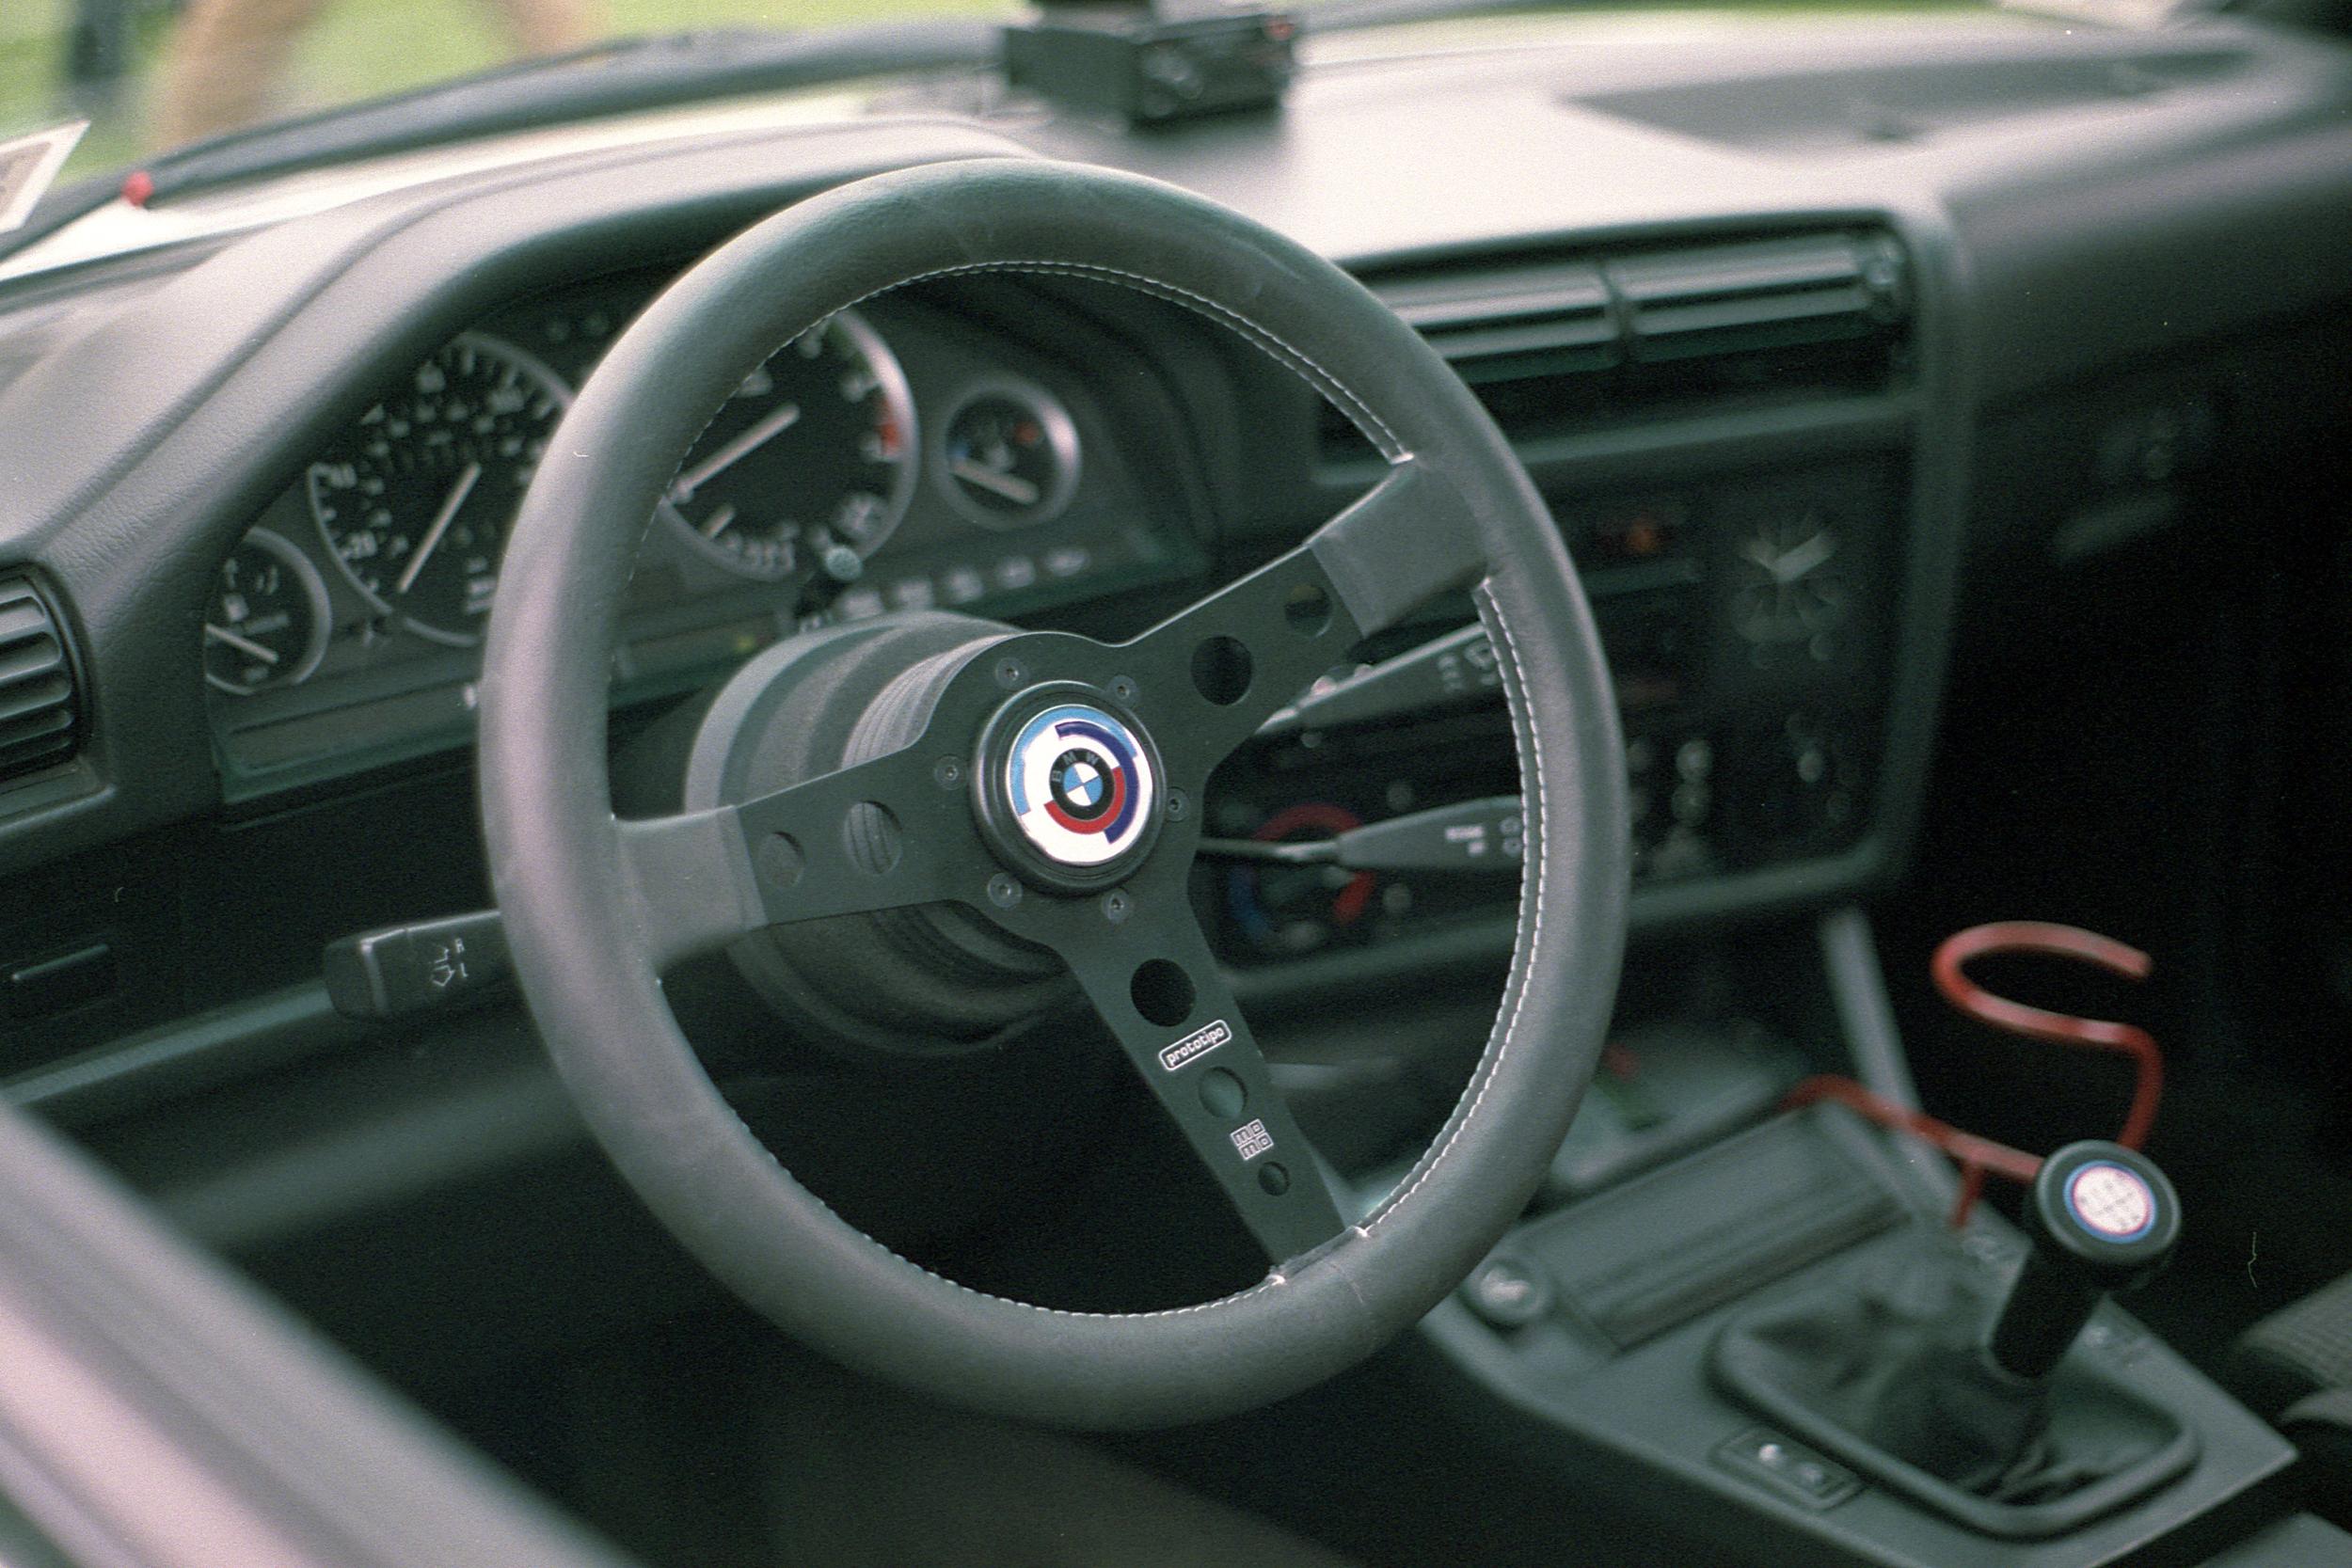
left=619, top=745, right=988, bottom=966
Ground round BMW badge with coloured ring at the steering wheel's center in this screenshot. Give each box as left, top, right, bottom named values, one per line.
left=1005, top=703, right=1160, bottom=865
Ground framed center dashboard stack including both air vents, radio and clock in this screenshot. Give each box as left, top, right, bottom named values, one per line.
left=1202, top=218, right=1964, bottom=985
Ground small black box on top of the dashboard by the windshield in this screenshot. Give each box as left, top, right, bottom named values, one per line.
left=1005, top=0, right=1298, bottom=124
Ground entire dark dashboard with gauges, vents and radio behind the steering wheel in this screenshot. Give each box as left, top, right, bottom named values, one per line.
left=0, top=6, right=2352, bottom=1104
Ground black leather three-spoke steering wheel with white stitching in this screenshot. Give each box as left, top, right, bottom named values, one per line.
left=480, top=157, right=1628, bottom=1427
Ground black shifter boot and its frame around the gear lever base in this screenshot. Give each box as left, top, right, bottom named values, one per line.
left=1712, top=1234, right=2197, bottom=1540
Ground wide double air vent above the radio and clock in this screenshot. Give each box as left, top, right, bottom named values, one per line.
left=1322, top=228, right=1910, bottom=463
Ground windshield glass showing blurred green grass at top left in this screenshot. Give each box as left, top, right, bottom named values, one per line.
left=0, top=0, right=2023, bottom=179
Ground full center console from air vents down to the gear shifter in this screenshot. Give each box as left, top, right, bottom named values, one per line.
left=1198, top=230, right=2352, bottom=1568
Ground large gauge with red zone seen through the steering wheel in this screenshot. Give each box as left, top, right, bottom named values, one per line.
left=661, top=310, right=915, bottom=580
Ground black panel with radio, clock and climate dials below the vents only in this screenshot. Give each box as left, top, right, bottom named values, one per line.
left=1207, top=456, right=1905, bottom=964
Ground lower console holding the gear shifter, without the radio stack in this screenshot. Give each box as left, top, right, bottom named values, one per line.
left=1374, top=917, right=2314, bottom=1568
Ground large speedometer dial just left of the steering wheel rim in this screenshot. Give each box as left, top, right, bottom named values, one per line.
left=309, top=331, right=572, bottom=644
